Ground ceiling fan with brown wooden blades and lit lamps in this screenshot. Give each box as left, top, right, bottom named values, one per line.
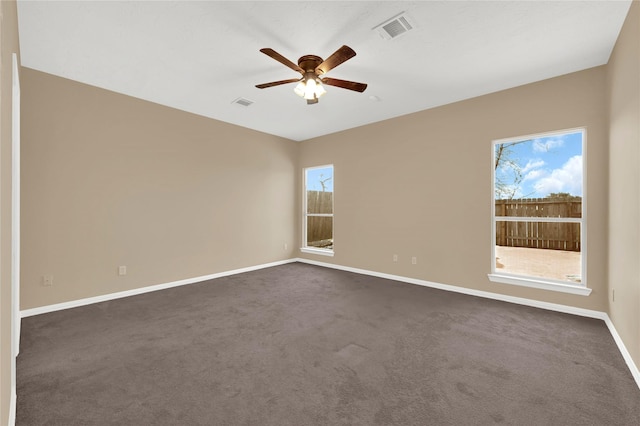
left=256, top=46, right=367, bottom=105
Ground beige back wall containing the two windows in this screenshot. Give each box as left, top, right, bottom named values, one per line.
left=300, top=67, right=608, bottom=311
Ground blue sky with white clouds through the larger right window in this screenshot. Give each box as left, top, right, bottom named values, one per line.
left=495, top=132, right=583, bottom=198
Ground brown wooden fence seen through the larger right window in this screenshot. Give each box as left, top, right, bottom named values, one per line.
left=495, top=197, right=582, bottom=251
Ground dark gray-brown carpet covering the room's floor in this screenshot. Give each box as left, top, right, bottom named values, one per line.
left=16, top=263, right=640, bottom=426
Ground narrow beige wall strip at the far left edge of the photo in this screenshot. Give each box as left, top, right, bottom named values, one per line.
left=0, top=1, right=19, bottom=425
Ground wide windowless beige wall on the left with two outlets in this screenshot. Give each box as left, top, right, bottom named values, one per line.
left=21, top=68, right=298, bottom=309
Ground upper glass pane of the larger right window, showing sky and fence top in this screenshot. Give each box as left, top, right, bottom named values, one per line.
left=494, top=131, right=583, bottom=218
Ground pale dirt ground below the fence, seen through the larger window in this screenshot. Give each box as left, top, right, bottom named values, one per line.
left=496, top=246, right=582, bottom=283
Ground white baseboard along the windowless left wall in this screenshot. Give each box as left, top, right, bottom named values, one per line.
left=20, top=259, right=296, bottom=318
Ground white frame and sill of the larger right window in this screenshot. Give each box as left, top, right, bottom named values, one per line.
left=488, top=127, right=591, bottom=296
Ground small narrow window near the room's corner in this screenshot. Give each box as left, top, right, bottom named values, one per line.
left=301, top=165, right=334, bottom=256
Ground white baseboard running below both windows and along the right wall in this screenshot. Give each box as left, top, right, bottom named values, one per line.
left=296, top=258, right=640, bottom=388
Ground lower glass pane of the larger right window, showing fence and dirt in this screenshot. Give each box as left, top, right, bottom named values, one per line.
left=496, top=221, right=582, bottom=283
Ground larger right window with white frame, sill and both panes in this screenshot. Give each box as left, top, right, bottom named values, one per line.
left=489, top=129, right=591, bottom=295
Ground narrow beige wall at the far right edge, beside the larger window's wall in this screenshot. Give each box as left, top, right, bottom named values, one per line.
left=607, top=1, right=640, bottom=366
